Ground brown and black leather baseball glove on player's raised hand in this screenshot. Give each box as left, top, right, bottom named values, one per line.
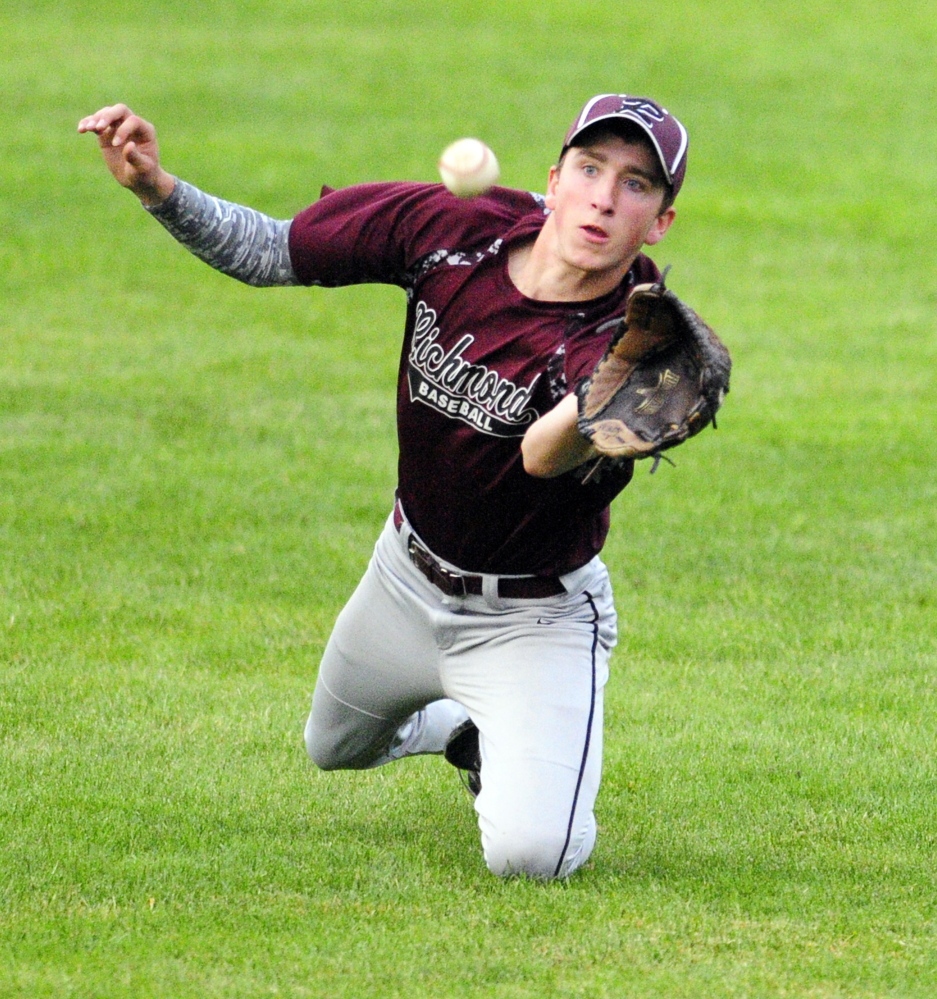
left=576, top=268, right=732, bottom=471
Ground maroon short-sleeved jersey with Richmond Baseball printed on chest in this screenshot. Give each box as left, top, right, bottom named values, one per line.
left=290, top=183, right=659, bottom=575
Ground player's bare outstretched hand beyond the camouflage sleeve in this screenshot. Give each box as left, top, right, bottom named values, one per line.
left=78, top=104, right=175, bottom=207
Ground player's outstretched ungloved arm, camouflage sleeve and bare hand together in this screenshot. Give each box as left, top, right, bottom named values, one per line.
left=78, top=104, right=298, bottom=287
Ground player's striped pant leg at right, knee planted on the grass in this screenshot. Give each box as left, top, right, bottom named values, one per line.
left=447, top=587, right=615, bottom=879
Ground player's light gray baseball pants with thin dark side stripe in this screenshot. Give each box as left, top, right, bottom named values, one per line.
left=305, top=518, right=616, bottom=878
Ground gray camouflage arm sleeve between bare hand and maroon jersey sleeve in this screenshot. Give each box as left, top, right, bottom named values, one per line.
left=147, top=178, right=299, bottom=288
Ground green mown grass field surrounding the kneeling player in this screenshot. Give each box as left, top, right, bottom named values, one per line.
left=0, top=0, right=937, bottom=999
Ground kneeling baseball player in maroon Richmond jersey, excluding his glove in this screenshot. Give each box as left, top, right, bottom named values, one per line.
left=79, top=94, right=687, bottom=879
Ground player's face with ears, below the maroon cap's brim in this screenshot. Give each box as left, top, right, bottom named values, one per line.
left=547, top=136, right=674, bottom=293
